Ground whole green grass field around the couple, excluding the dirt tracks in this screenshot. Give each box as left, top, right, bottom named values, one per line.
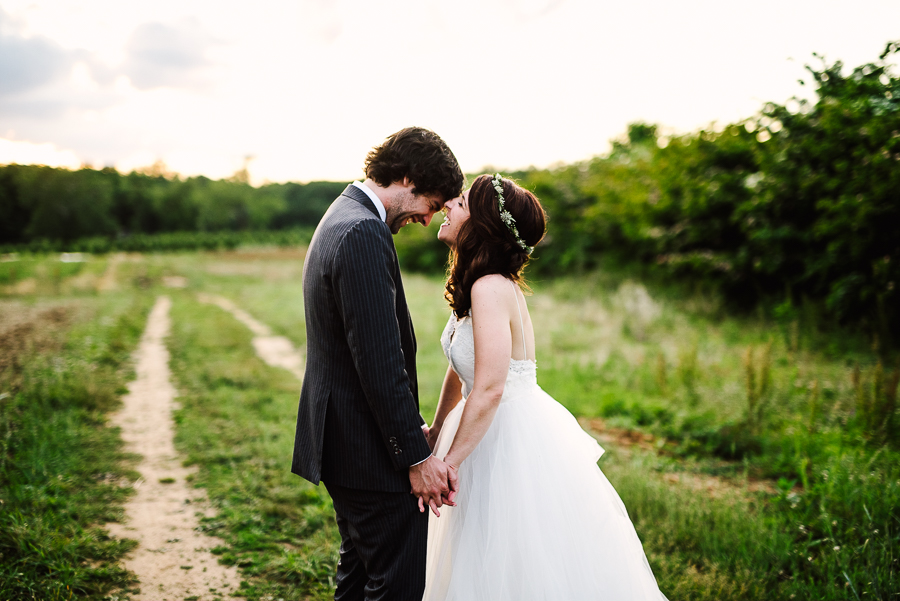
left=0, top=248, right=900, bottom=600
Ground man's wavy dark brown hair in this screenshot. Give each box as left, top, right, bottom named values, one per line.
left=365, top=127, right=466, bottom=201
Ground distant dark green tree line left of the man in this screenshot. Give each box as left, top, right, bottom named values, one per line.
left=0, top=165, right=345, bottom=250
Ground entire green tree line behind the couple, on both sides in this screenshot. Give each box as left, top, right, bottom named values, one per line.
left=0, top=42, right=900, bottom=346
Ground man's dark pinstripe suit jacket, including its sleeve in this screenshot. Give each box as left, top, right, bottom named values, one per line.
left=291, top=186, right=431, bottom=492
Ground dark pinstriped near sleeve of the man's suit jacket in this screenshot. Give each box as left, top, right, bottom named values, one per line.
left=332, top=219, right=431, bottom=470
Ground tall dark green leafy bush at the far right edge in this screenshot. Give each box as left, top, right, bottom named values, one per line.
left=745, top=42, right=900, bottom=336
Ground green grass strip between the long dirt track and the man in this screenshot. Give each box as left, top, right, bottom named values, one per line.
left=169, top=294, right=337, bottom=599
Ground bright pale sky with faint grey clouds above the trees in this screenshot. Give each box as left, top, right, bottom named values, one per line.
left=0, top=0, right=900, bottom=184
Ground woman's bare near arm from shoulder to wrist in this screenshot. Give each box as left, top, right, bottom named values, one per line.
left=444, top=275, right=512, bottom=468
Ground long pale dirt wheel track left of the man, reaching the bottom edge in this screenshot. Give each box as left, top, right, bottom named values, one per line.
left=107, top=296, right=240, bottom=601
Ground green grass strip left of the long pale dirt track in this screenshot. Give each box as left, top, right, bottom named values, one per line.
left=0, top=295, right=148, bottom=600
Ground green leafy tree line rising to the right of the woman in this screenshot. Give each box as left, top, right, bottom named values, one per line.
left=519, top=42, right=900, bottom=346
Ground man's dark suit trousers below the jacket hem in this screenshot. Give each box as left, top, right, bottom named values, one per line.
left=325, top=482, right=428, bottom=601
